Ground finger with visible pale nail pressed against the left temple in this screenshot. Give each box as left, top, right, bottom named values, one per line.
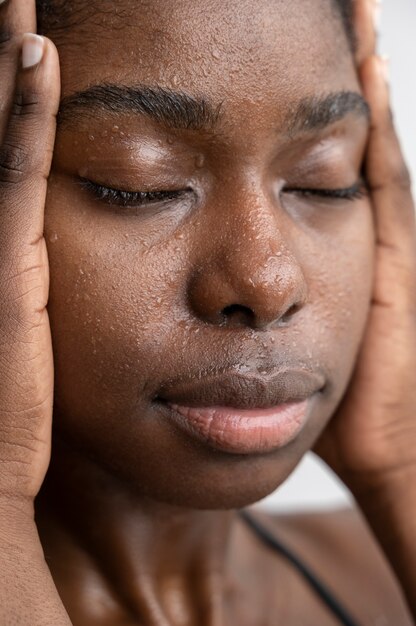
left=0, top=34, right=60, bottom=264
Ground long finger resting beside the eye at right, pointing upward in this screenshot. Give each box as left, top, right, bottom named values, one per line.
left=361, top=56, right=416, bottom=313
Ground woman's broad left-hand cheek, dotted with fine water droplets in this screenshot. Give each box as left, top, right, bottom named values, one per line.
left=46, top=200, right=184, bottom=424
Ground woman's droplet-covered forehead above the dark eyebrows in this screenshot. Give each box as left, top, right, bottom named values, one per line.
left=50, top=0, right=355, bottom=103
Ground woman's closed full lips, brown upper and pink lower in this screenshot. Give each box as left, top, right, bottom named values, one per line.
left=158, top=369, right=324, bottom=455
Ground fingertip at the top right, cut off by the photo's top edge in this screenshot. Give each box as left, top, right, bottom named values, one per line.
left=353, top=0, right=381, bottom=67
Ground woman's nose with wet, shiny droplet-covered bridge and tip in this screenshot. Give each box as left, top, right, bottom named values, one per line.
left=188, top=191, right=307, bottom=330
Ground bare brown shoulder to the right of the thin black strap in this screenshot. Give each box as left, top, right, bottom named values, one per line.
left=256, top=509, right=413, bottom=626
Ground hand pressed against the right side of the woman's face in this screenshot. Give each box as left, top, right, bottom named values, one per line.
left=316, top=3, right=416, bottom=494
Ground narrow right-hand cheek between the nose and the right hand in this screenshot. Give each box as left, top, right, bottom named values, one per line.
left=308, top=202, right=374, bottom=397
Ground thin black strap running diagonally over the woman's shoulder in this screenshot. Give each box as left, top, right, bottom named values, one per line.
left=239, top=511, right=359, bottom=626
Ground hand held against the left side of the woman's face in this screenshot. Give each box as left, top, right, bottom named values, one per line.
left=0, top=0, right=60, bottom=516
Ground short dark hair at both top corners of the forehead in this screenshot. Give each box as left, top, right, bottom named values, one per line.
left=36, top=0, right=355, bottom=50
